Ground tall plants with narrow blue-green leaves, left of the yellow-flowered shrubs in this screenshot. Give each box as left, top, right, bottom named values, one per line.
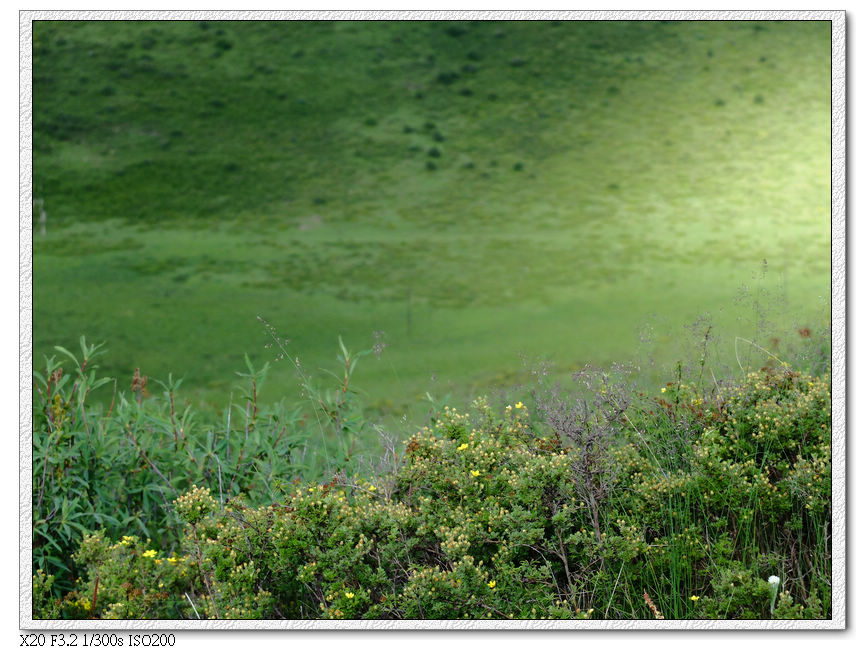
left=32, top=338, right=320, bottom=594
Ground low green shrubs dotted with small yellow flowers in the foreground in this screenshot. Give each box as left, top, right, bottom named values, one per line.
left=40, top=367, right=831, bottom=619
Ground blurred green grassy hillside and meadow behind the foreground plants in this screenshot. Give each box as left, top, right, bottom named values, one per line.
left=33, top=21, right=831, bottom=415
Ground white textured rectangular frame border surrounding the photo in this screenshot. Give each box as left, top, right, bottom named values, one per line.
left=19, top=11, right=847, bottom=631
